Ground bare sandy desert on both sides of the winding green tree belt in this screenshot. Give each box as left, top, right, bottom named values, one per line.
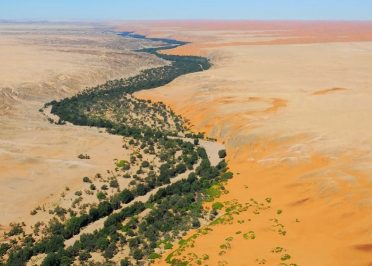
left=0, top=21, right=372, bottom=265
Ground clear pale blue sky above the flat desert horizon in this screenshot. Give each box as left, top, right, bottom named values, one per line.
left=0, top=0, right=372, bottom=21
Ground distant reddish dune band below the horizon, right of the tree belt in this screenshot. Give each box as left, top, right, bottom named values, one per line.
left=117, top=21, right=372, bottom=55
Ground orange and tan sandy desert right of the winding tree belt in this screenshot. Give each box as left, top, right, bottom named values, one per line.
left=132, top=22, right=372, bottom=265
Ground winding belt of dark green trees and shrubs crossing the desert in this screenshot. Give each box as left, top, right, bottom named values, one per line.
left=0, top=33, right=232, bottom=266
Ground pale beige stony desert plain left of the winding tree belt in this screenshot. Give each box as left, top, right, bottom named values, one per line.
left=0, top=23, right=164, bottom=231
